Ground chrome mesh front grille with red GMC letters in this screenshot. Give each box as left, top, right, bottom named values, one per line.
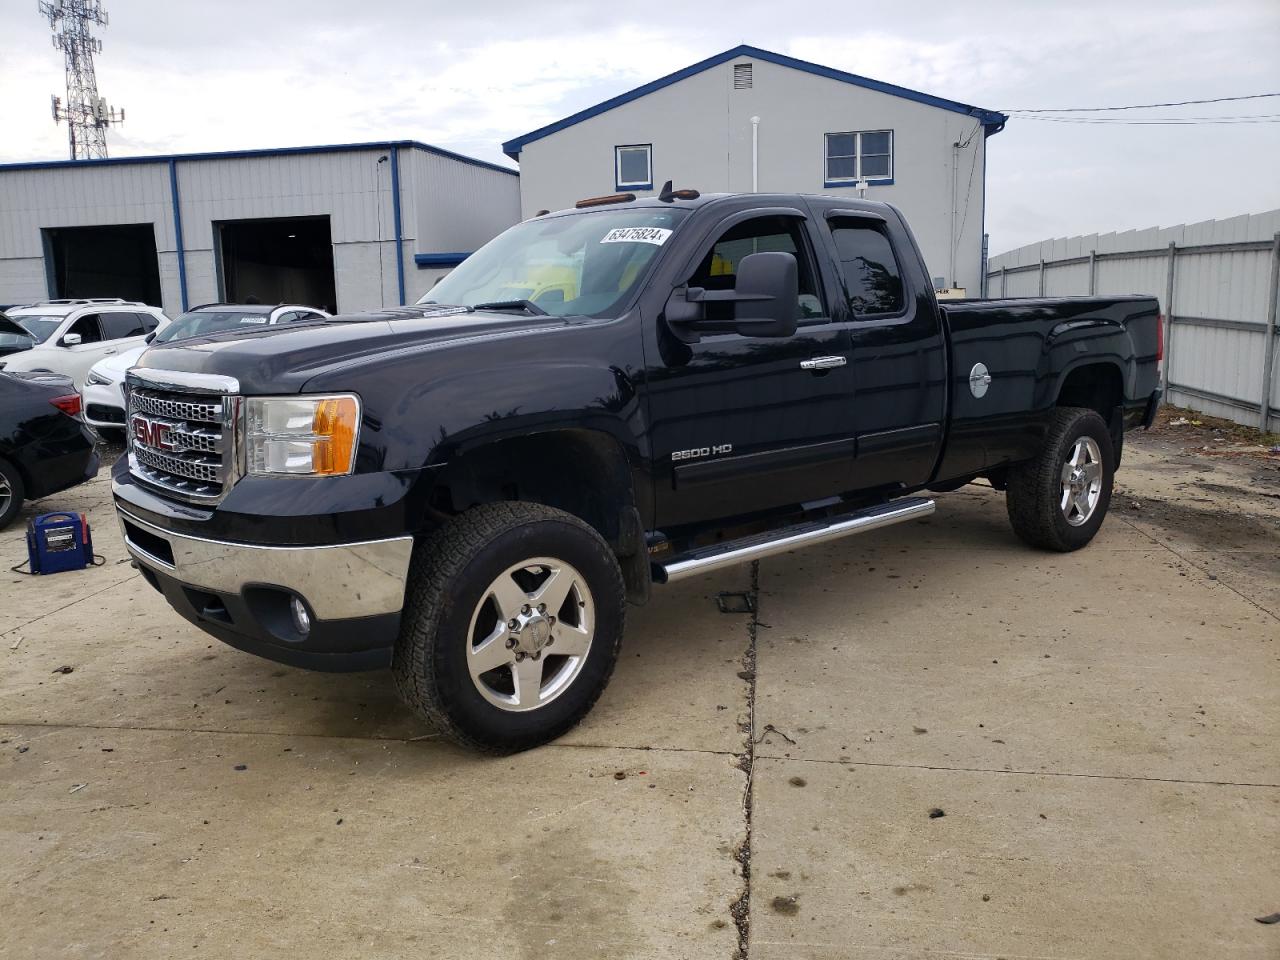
left=125, top=372, right=239, bottom=503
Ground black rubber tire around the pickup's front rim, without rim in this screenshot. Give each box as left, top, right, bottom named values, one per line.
left=392, top=502, right=626, bottom=754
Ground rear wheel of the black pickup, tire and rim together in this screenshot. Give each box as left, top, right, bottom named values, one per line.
left=1005, top=407, right=1115, bottom=553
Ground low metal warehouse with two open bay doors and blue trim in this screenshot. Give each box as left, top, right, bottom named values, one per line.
left=0, top=141, right=520, bottom=316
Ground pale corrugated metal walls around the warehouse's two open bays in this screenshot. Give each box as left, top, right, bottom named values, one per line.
left=0, top=142, right=520, bottom=316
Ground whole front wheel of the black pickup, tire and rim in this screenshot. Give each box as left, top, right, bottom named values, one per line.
left=393, top=503, right=625, bottom=753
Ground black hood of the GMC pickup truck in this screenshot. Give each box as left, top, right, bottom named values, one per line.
left=134, top=305, right=582, bottom=394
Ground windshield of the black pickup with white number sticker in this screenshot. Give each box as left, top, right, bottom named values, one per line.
left=419, top=207, right=687, bottom=317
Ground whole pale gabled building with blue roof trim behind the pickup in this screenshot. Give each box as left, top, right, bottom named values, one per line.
left=503, top=46, right=1007, bottom=296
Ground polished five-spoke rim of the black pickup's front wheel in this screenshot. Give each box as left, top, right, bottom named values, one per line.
left=467, top=557, right=595, bottom=712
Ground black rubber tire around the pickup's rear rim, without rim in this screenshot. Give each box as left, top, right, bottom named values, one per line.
left=1005, top=407, right=1115, bottom=553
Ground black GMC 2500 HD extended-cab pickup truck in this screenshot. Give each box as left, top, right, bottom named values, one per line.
left=113, top=188, right=1162, bottom=751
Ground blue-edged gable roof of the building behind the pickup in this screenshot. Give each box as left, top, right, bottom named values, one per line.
left=502, top=44, right=1009, bottom=160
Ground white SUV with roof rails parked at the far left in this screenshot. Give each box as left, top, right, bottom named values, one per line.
left=0, top=298, right=169, bottom=390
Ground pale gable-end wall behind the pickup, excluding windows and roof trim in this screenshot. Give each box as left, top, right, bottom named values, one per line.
left=509, top=55, right=986, bottom=296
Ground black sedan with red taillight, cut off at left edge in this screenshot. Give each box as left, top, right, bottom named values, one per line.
left=0, top=372, right=97, bottom=529
